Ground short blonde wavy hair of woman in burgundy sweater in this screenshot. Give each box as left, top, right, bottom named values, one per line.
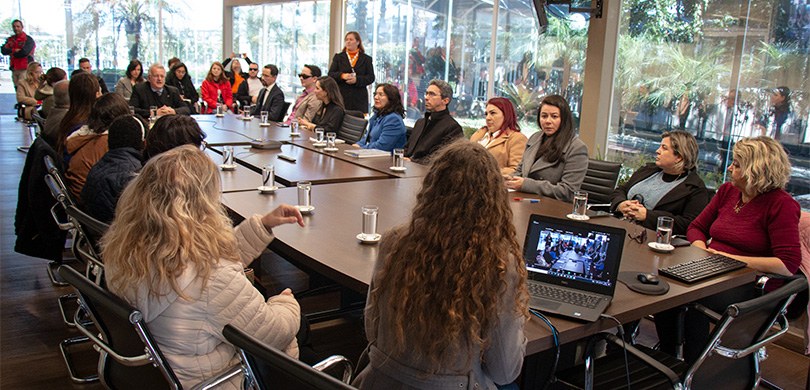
left=733, top=136, right=790, bottom=195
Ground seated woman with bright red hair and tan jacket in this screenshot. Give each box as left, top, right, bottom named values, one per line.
left=470, top=97, right=528, bottom=175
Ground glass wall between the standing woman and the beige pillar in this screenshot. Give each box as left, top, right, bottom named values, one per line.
left=345, top=0, right=587, bottom=135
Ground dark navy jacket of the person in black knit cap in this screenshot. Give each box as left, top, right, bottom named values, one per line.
left=82, top=147, right=141, bottom=223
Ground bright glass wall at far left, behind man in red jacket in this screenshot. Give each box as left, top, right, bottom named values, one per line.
left=0, top=0, right=222, bottom=88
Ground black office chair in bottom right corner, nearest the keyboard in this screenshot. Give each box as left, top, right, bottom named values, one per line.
left=557, top=276, right=807, bottom=389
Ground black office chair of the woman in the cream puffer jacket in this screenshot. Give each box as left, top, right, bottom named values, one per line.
left=58, top=266, right=243, bottom=389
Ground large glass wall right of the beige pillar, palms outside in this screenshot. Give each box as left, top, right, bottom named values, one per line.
left=608, top=0, right=810, bottom=209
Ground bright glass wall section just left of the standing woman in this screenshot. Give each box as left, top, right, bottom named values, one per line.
left=233, top=1, right=331, bottom=100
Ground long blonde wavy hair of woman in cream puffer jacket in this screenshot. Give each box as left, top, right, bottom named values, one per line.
left=101, top=145, right=239, bottom=298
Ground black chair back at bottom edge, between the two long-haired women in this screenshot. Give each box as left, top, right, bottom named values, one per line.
left=222, top=325, right=354, bottom=390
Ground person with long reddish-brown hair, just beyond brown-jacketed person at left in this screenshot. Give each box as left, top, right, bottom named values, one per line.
left=56, top=70, right=101, bottom=155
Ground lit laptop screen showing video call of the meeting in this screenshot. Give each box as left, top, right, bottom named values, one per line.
left=525, top=223, right=612, bottom=287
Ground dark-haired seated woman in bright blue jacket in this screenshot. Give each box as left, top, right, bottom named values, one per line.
left=354, top=84, right=405, bottom=152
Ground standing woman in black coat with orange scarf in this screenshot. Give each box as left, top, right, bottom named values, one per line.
left=329, top=31, right=374, bottom=114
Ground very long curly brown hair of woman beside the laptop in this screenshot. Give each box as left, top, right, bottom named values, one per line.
left=366, top=142, right=528, bottom=370
